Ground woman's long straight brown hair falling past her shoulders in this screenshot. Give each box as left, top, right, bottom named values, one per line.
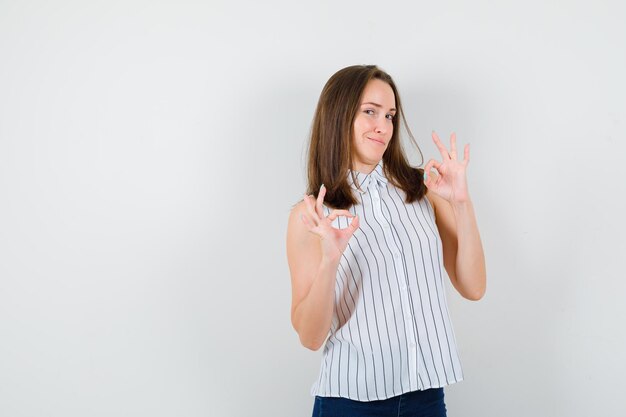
left=307, top=65, right=426, bottom=209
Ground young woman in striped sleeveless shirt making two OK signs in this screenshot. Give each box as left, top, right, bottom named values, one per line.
left=287, top=66, right=486, bottom=417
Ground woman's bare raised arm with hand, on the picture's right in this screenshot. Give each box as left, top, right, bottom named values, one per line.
left=424, top=132, right=487, bottom=300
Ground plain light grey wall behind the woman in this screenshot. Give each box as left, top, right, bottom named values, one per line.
left=0, top=0, right=626, bottom=417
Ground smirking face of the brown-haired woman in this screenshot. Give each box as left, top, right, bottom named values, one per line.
left=352, top=79, right=396, bottom=173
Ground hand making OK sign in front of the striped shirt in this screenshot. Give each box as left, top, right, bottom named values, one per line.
left=300, top=184, right=359, bottom=259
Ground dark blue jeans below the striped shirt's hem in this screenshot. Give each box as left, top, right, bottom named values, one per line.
left=313, top=388, right=446, bottom=417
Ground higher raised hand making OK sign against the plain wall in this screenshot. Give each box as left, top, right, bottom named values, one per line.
left=424, top=131, right=469, bottom=204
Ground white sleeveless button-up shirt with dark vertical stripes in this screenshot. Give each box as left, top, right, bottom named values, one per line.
left=311, top=161, right=463, bottom=401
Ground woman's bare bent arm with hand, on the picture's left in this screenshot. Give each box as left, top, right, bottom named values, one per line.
left=287, top=188, right=359, bottom=350
